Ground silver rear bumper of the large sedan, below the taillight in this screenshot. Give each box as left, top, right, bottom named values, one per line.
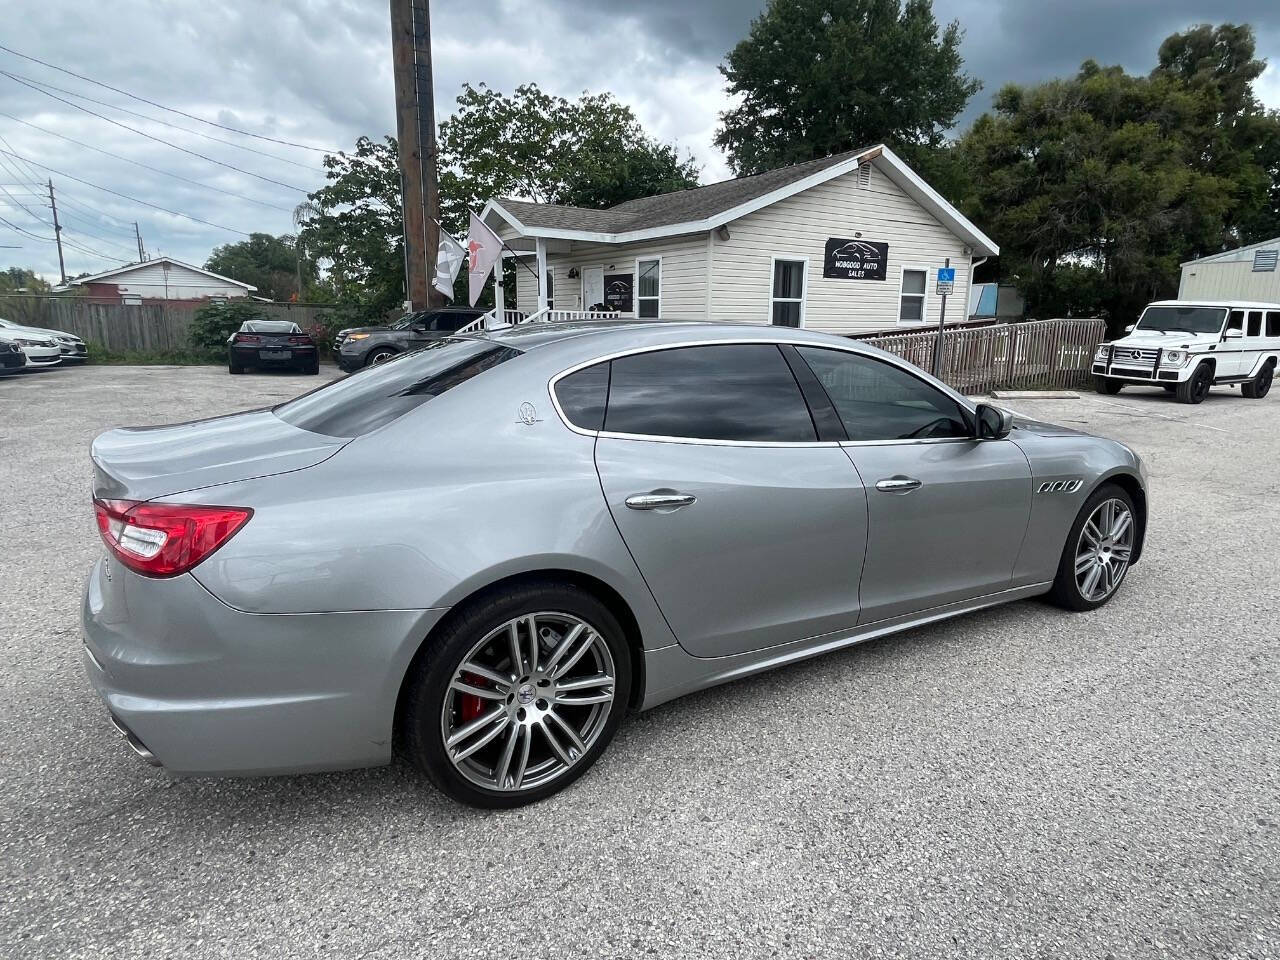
left=82, top=559, right=443, bottom=776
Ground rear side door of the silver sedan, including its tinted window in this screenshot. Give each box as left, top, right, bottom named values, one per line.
left=581, top=343, right=867, bottom=657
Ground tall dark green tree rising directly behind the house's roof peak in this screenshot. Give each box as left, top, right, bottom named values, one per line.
left=716, top=0, right=982, bottom=175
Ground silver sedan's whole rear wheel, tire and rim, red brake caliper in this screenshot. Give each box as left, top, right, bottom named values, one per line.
left=399, top=582, right=631, bottom=808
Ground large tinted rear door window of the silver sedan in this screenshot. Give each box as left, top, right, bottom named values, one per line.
left=604, top=343, right=817, bottom=443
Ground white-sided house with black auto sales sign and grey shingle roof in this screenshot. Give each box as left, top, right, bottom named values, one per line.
left=481, top=146, right=1000, bottom=333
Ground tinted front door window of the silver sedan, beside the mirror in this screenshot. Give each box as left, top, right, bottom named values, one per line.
left=796, top=347, right=969, bottom=440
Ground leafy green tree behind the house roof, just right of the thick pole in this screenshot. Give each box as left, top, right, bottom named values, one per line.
left=439, top=83, right=698, bottom=230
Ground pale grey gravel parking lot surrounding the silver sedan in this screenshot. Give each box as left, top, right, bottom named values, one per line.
left=0, top=366, right=1280, bottom=960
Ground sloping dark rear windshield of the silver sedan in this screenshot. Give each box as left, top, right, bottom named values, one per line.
left=273, top=339, right=521, bottom=438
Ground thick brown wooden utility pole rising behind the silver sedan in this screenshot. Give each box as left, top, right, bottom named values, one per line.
left=390, top=0, right=444, bottom=310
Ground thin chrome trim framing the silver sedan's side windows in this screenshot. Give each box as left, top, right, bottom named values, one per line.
left=547, top=337, right=986, bottom=448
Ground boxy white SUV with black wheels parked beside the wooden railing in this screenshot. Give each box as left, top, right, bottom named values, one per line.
left=1093, top=300, right=1280, bottom=403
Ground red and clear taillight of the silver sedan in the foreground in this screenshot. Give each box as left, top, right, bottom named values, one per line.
left=93, top=499, right=253, bottom=577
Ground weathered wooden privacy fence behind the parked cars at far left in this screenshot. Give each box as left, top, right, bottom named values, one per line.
left=0, top=297, right=333, bottom=353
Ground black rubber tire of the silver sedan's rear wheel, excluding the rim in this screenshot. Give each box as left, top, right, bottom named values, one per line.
left=397, top=580, right=632, bottom=809
